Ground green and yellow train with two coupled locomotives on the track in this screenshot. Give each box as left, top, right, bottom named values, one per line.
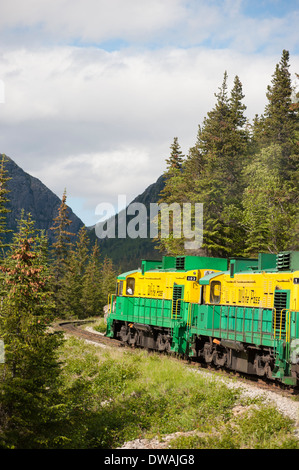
left=106, top=251, right=299, bottom=387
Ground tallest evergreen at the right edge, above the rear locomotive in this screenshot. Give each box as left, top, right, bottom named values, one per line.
left=243, top=50, right=299, bottom=253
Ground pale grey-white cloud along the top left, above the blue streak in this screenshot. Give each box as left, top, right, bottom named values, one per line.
left=0, top=0, right=184, bottom=41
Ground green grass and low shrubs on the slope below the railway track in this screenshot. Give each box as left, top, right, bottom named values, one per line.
left=57, top=338, right=299, bottom=449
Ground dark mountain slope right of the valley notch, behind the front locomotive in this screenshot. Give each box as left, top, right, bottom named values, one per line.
left=89, top=175, right=165, bottom=272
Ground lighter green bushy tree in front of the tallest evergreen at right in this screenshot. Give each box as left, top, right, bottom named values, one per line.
left=243, top=144, right=297, bottom=255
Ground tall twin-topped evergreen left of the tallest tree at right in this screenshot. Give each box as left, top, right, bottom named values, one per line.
left=187, top=72, right=249, bottom=256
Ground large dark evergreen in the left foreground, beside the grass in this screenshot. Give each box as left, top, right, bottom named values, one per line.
left=0, top=215, right=61, bottom=448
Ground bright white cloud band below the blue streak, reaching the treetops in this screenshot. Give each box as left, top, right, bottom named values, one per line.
left=0, top=47, right=282, bottom=126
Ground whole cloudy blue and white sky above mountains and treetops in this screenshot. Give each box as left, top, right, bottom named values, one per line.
left=0, top=0, right=299, bottom=226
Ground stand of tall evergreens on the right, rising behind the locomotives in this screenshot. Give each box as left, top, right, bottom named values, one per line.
left=158, top=50, right=299, bottom=256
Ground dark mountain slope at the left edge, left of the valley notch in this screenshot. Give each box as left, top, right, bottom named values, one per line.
left=0, top=154, right=84, bottom=243
